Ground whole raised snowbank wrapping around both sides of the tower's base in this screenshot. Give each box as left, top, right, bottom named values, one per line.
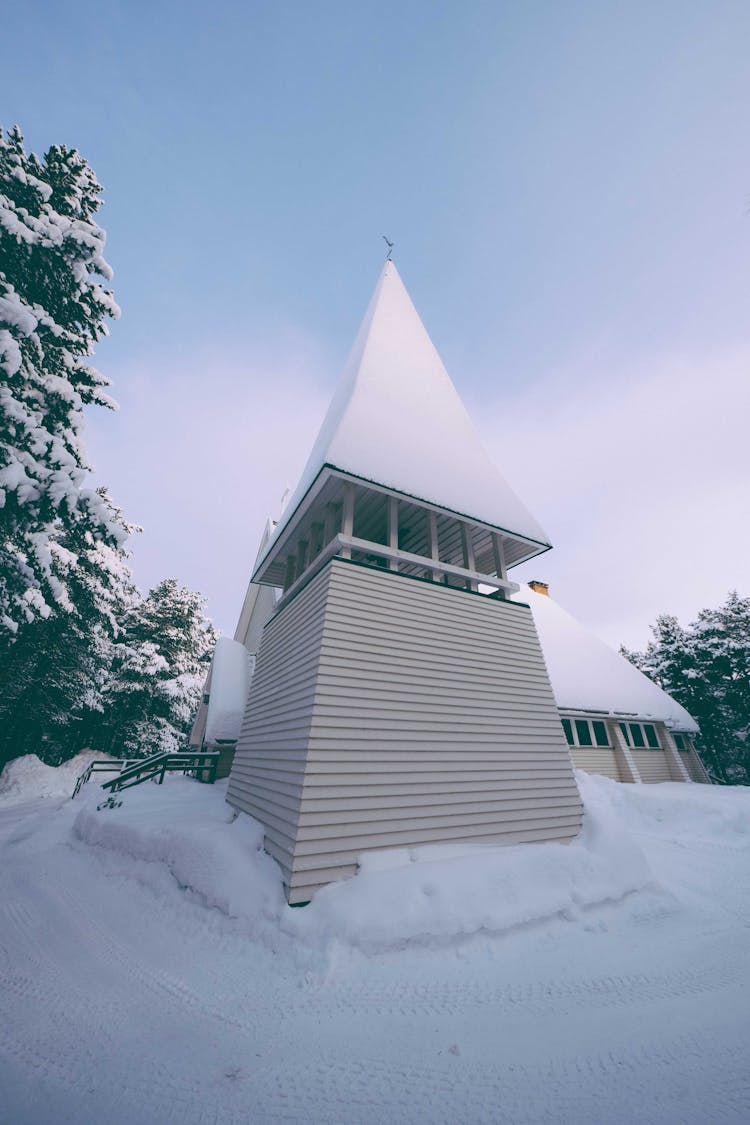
left=67, top=774, right=688, bottom=954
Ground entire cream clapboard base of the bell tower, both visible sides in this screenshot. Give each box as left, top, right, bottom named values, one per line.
left=228, top=559, right=581, bottom=902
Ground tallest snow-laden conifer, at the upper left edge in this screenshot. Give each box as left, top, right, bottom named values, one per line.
left=0, top=128, right=125, bottom=641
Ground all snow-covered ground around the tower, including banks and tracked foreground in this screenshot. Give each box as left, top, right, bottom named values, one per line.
left=0, top=759, right=750, bottom=1125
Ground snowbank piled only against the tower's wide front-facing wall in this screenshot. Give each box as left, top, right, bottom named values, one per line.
left=287, top=775, right=653, bottom=953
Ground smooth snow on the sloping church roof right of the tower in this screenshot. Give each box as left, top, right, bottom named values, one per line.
left=514, top=585, right=698, bottom=731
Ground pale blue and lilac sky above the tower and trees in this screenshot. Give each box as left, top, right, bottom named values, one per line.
left=0, top=0, right=750, bottom=645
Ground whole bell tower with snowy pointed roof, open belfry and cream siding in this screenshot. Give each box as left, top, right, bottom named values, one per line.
left=227, top=261, right=581, bottom=903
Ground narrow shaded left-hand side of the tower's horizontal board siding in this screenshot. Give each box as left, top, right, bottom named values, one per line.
left=222, top=570, right=328, bottom=883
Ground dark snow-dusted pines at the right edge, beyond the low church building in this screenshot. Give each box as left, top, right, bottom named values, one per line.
left=622, top=592, right=750, bottom=784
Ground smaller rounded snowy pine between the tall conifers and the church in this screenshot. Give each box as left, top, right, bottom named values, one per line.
left=97, top=578, right=216, bottom=757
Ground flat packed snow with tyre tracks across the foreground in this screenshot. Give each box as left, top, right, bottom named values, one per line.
left=0, top=805, right=750, bottom=1125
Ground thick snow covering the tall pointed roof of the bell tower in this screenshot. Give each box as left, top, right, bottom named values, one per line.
left=264, top=261, right=549, bottom=562
